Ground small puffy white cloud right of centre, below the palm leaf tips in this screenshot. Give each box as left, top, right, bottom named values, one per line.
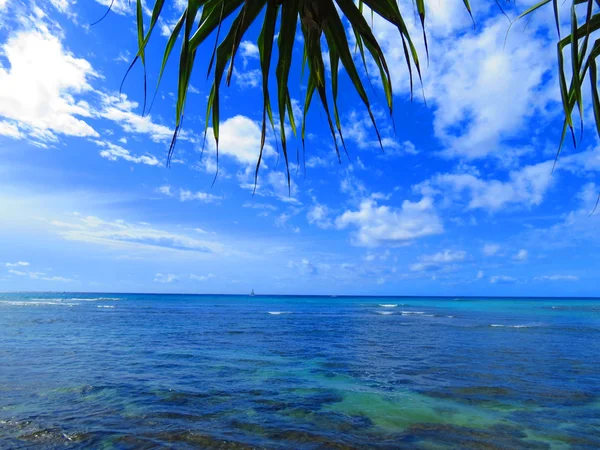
left=335, top=197, right=444, bottom=247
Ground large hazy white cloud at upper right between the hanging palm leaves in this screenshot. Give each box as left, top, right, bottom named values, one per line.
left=371, top=5, right=558, bottom=160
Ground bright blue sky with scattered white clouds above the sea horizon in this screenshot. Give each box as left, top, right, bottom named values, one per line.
left=0, top=0, right=600, bottom=296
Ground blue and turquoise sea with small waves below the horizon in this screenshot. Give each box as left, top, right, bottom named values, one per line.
left=0, top=293, right=600, bottom=449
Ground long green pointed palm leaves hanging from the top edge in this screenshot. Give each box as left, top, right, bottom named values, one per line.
left=103, top=0, right=600, bottom=192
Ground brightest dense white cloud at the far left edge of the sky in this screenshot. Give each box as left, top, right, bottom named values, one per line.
left=0, top=24, right=98, bottom=141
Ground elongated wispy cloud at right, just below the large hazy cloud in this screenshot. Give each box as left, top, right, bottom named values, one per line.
left=413, top=161, right=553, bottom=212
